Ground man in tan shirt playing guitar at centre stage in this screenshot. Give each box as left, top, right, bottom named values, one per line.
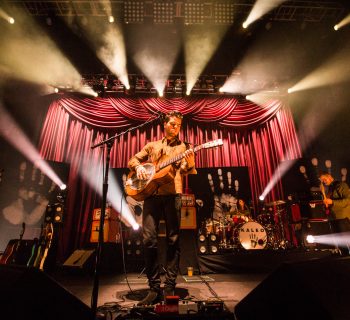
left=128, top=111, right=197, bottom=305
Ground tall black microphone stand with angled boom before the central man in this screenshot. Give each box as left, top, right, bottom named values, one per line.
left=91, top=113, right=162, bottom=319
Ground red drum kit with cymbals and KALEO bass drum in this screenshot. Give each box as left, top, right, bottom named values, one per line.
left=200, top=200, right=288, bottom=250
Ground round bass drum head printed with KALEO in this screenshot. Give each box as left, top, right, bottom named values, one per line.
left=237, top=221, right=267, bottom=250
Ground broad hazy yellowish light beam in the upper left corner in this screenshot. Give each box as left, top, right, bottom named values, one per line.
left=0, top=10, right=81, bottom=87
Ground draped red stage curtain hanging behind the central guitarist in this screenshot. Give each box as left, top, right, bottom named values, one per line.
left=40, top=97, right=301, bottom=253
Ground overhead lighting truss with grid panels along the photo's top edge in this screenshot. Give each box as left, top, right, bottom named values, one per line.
left=5, top=0, right=346, bottom=24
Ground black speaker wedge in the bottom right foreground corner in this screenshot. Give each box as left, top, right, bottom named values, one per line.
left=234, top=257, right=350, bottom=320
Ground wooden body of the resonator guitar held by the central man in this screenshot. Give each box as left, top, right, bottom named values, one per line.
left=125, top=163, right=175, bottom=201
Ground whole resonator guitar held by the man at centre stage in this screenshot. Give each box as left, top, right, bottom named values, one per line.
left=125, top=139, right=223, bottom=201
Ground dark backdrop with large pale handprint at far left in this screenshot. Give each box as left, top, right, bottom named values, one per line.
left=0, top=152, right=69, bottom=251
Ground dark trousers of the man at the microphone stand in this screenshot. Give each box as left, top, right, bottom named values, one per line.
left=143, top=195, right=181, bottom=291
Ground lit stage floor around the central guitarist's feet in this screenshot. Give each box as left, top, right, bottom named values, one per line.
left=51, top=252, right=339, bottom=312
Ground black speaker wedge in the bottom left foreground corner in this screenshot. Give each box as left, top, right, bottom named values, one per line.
left=0, top=265, right=93, bottom=320
